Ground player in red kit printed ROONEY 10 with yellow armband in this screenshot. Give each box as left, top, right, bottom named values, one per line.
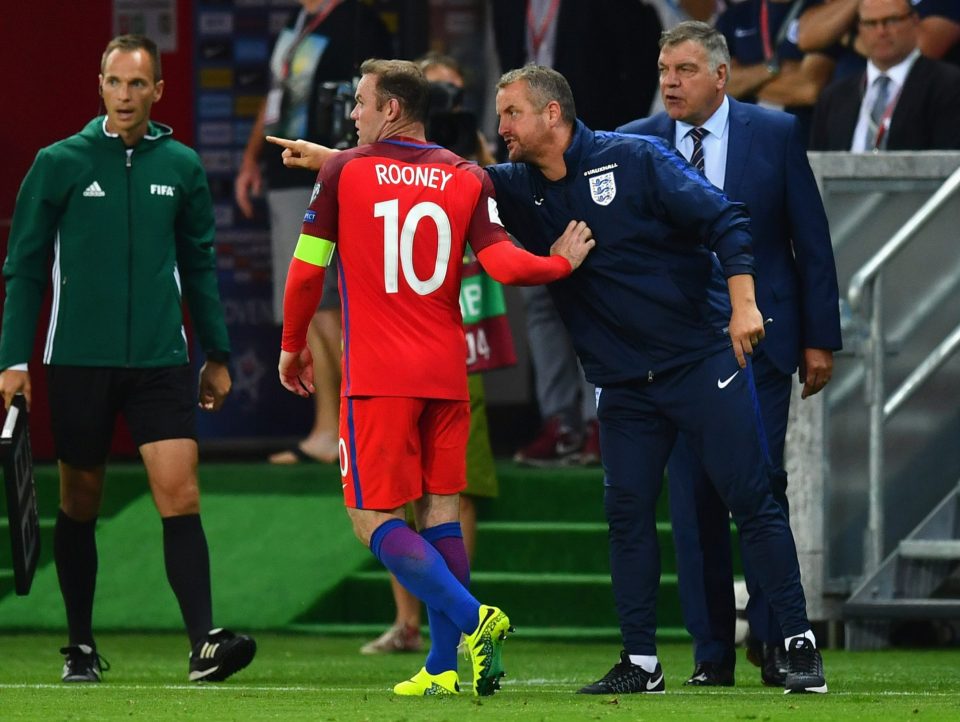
left=279, top=60, right=594, bottom=695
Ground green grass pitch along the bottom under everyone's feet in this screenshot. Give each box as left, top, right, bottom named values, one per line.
left=0, top=630, right=960, bottom=722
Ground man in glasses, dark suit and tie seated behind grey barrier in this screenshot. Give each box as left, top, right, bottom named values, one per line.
left=810, top=0, right=960, bottom=152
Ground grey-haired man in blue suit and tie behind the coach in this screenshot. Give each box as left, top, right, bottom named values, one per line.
left=619, top=22, right=841, bottom=686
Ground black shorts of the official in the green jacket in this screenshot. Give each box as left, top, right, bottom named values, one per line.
left=47, top=365, right=197, bottom=466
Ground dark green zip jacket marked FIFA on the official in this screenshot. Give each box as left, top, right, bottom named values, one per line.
left=0, top=116, right=230, bottom=369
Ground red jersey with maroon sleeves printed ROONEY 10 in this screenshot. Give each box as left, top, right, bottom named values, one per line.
left=301, top=137, right=508, bottom=400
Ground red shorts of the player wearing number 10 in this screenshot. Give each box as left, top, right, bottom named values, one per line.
left=340, top=396, right=470, bottom=511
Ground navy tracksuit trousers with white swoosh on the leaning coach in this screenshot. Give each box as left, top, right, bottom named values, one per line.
left=597, top=348, right=810, bottom=654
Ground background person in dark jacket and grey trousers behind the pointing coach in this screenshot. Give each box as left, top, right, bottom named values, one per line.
left=491, top=0, right=661, bottom=467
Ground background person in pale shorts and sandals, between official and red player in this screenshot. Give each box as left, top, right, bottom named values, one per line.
left=234, top=0, right=393, bottom=464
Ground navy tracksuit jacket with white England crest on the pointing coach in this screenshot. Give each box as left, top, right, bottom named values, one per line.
left=487, top=121, right=753, bottom=386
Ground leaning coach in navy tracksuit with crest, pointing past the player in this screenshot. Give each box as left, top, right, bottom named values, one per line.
left=487, top=66, right=827, bottom=694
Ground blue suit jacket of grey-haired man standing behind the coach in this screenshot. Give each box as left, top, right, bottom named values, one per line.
left=618, top=98, right=841, bottom=373
